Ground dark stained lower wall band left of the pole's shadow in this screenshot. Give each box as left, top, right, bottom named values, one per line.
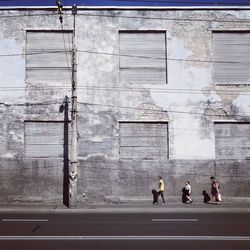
left=0, top=158, right=63, bottom=202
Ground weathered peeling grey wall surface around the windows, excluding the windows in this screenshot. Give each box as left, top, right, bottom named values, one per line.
left=0, top=9, right=250, bottom=202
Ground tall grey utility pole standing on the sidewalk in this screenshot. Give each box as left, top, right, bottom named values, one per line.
left=69, top=5, right=77, bottom=208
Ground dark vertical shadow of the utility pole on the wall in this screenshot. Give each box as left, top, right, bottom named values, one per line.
left=60, top=96, right=69, bottom=207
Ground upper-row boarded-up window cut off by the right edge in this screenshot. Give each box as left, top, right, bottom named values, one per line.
left=213, top=32, right=250, bottom=84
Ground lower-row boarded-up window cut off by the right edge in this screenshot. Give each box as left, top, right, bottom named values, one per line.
left=214, top=122, right=250, bottom=159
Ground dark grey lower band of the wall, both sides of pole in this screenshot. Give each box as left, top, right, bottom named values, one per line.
left=0, top=157, right=250, bottom=203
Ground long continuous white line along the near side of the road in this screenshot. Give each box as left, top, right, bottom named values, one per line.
left=0, top=236, right=250, bottom=241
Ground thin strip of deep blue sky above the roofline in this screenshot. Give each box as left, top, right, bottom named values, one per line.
left=0, top=0, right=250, bottom=6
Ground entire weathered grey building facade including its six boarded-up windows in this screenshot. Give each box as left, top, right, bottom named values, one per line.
left=0, top=7, right=250, bottom=202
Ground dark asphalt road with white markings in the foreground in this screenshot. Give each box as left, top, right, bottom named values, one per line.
left=0, top=213, right=250, bottom=250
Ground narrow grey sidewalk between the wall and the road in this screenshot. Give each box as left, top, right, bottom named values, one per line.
left=0, top=201, right=250, bottom=213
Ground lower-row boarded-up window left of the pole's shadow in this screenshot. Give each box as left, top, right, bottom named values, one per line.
left=24, top=121, right=70, bottom=158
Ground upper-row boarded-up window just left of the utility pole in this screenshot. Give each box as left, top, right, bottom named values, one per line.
left=26, top=31, right=72, bottom=85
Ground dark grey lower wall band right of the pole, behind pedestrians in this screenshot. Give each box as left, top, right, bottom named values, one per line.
left=79, top=158, right=250, bottom=200
